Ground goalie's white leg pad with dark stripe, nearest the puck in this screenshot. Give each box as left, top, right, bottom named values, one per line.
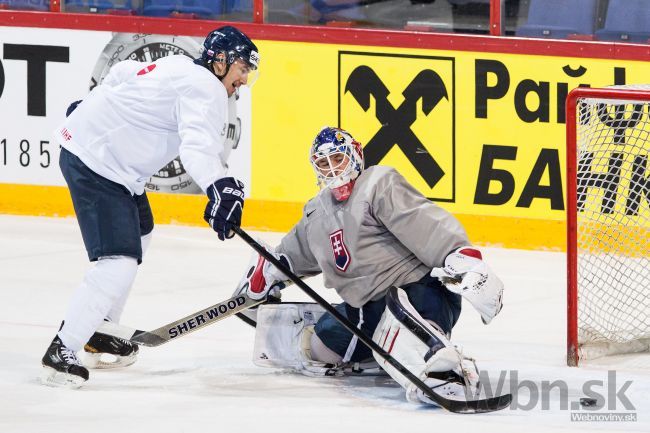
left=372, top=287, right=478, bottom=404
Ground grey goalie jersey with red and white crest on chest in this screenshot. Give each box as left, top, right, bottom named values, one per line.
left=276, top=166, right=469, bottom=308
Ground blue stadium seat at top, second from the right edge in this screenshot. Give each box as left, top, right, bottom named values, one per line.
left=515, top=0, right=599, bottom=39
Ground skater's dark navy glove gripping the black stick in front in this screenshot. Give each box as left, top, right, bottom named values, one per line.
left=203, top=177, right=244, bottom=241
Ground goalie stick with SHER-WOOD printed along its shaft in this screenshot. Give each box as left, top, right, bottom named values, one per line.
left=97, top=288, right=266, bottom=347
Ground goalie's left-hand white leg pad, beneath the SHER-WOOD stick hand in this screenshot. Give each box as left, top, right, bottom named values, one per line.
left=253, top=303, right=343, bottom=376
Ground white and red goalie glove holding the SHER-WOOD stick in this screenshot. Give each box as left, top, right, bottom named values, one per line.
left=238, top=246, right=293, bottom=300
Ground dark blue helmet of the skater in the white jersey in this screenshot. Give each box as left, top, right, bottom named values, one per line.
left=199, top=26, right=260, bottom=70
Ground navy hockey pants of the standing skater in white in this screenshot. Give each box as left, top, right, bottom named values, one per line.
left=59, top=148, right=153, bottom=263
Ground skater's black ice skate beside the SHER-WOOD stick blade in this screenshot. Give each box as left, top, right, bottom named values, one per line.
left=84, top=333, right=139, bottom=368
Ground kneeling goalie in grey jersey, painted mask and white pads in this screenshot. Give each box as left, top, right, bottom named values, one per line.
left=239, top=127, right=503, bottom=403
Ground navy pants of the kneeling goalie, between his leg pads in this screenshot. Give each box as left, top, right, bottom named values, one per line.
left=314, top=274, right=461, bottom=362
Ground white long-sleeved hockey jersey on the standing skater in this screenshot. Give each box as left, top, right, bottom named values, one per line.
left=54, top=55, right=230, bottom=195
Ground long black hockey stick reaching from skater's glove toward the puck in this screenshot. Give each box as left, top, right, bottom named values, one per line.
left=232, top=227, right=512, bottom=413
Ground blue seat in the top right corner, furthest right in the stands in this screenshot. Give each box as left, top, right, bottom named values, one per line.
left=596, top=0, right=650, bottom=43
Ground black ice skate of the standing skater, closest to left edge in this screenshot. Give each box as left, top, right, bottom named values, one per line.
left=41, top=335, right=88, bottom=388
